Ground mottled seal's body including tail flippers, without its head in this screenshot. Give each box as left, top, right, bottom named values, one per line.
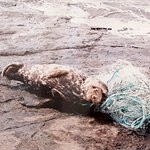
left=3, top=64, right=85, bottom=101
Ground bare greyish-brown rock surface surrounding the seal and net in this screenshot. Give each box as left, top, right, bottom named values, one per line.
left=0, top=0, right=150, bottom=150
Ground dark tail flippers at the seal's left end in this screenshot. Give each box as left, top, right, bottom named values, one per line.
left=1, top=63, right=23, bottom=79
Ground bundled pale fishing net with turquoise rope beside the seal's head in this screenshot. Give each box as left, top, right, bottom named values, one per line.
left=96, top=61, right=150, bottom=130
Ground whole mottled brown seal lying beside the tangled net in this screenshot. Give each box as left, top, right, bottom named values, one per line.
left=2, top=63, right=108, bottom=104
